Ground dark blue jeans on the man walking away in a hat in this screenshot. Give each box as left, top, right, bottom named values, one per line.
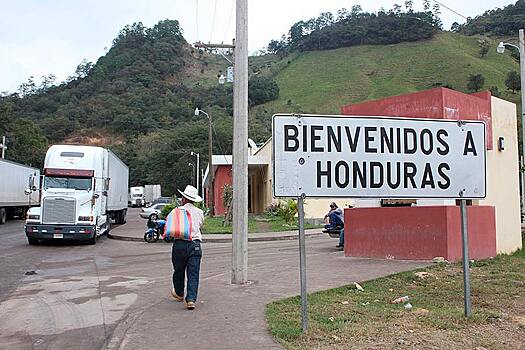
left=171, top=239, right=202, bottom=302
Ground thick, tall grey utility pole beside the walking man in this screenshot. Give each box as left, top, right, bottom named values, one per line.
left=232, top=0, right=248, bottom=284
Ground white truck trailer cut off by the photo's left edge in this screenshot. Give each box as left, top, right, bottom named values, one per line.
left=0, top=159, right=40, bottom=224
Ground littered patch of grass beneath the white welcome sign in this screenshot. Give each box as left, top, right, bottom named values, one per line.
left=266, top=250, right=525, bottom=349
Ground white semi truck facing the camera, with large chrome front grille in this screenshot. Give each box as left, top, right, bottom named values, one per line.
left=25, top=145, right=129, bottom=244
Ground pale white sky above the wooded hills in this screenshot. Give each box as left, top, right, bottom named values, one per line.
left=0, top=0, right=515, bottom=91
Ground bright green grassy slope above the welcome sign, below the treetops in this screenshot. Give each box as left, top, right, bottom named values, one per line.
left=255, top=32, right=519, bottom=113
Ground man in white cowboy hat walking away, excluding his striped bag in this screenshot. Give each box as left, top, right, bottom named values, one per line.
left=171, top=185, right=204, bottom=310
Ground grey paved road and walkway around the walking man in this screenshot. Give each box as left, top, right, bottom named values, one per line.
left=0, top=210, right=424, bottom=349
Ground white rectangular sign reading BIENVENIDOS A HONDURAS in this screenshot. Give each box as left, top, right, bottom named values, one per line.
left=272, top=114, right=486, bottom=198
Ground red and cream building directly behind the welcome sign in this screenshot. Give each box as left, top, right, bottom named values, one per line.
left=341, top=88, right=522, bottom=261
